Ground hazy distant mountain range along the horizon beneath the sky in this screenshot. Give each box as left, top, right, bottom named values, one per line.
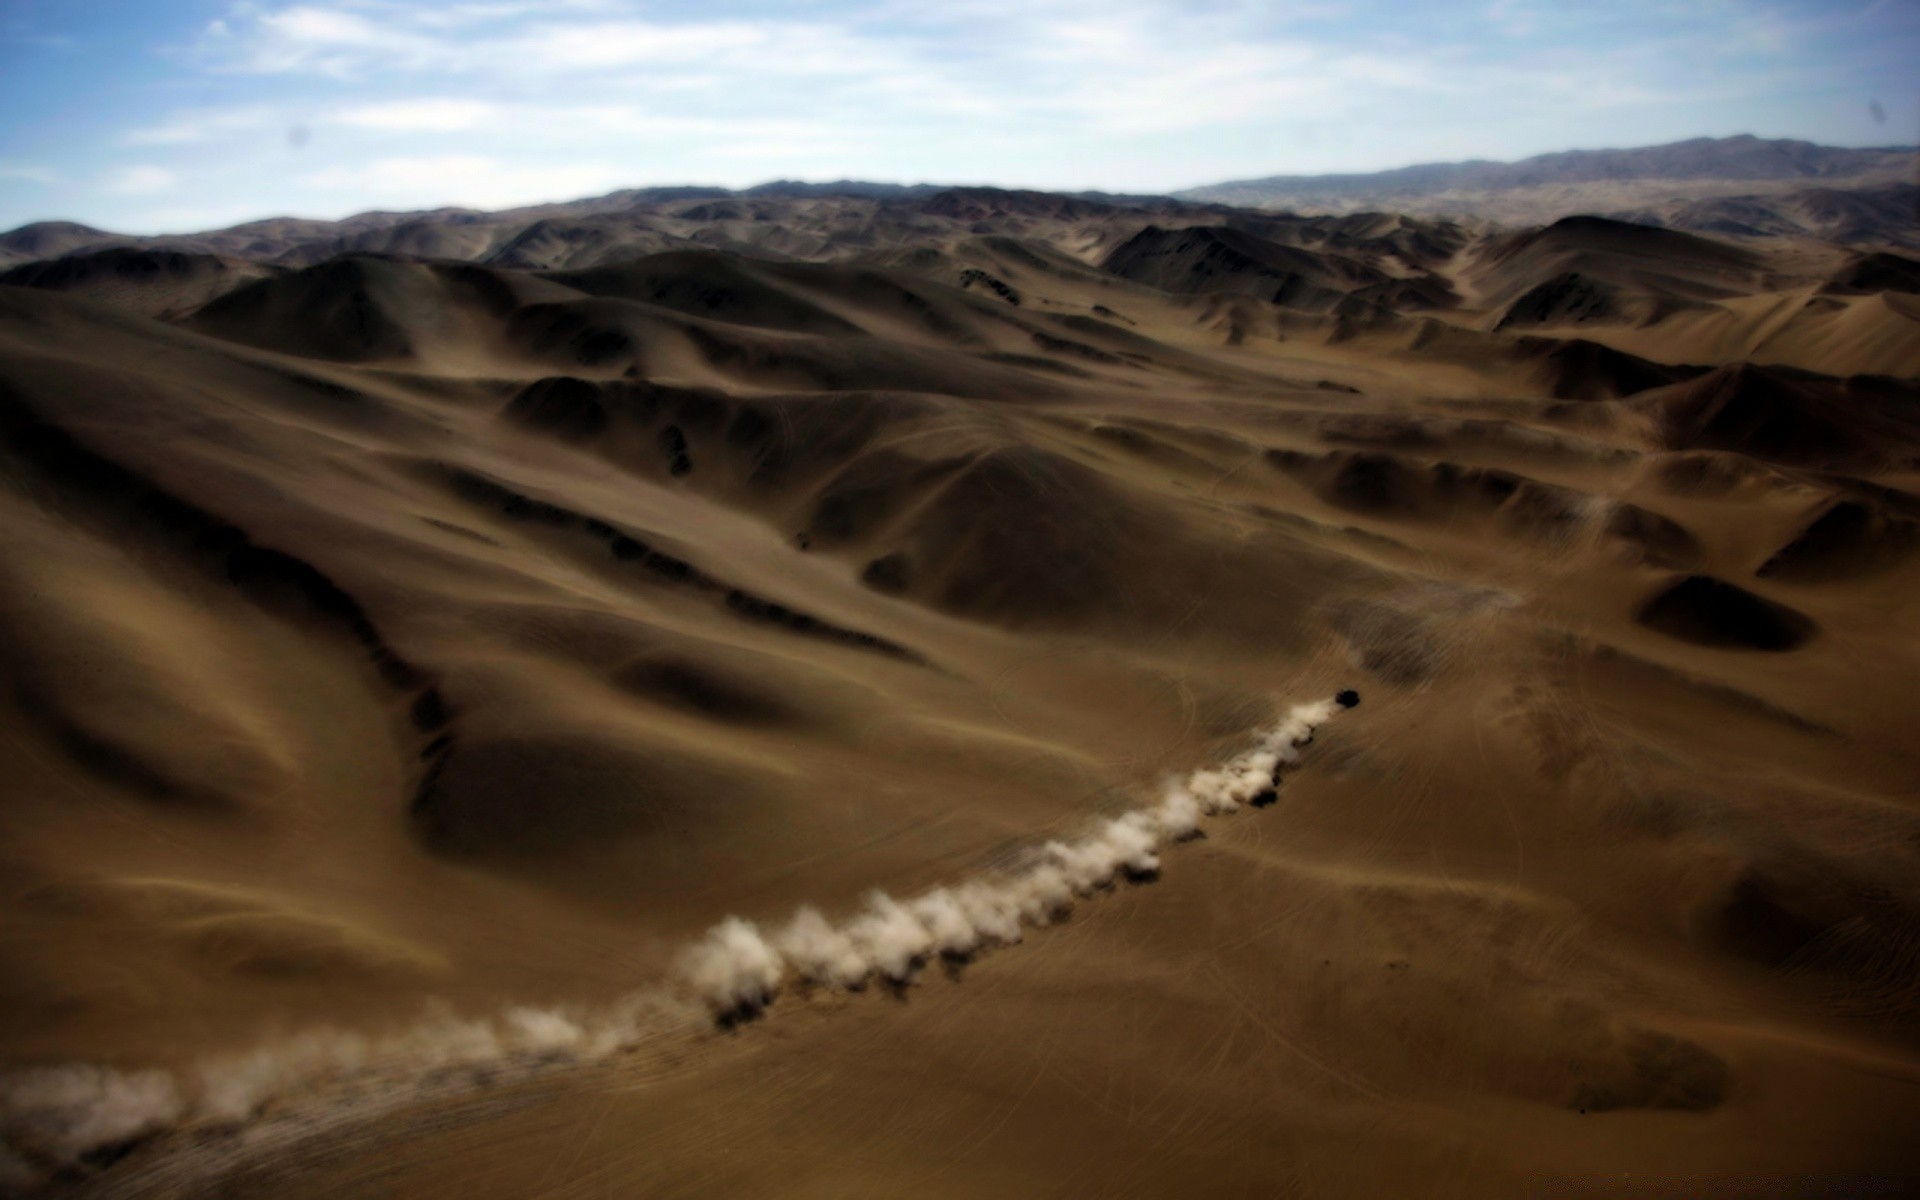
left=0, top=136, right=1920, bottom=269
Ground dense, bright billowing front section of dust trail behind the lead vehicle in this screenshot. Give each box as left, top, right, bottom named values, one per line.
left=680, top=691, right=1359, bottom=1023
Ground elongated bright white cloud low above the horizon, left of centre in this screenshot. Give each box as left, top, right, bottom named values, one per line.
left=296, top=154, right=630, bottom=207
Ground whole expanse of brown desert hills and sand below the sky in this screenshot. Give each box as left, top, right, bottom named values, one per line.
left=0, top=126, right=1920, bottom=1200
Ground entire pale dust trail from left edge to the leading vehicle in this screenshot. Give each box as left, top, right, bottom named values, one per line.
left=0, top=691, right=1359, bottom=1196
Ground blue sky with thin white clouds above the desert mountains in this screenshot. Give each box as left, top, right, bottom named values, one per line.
left=0, top=0, right=1920, bottom=232
